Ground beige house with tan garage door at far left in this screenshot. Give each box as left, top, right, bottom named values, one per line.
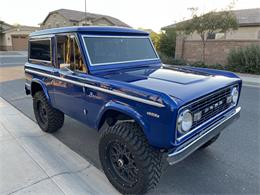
left=0, top=23, right=39, bottom=51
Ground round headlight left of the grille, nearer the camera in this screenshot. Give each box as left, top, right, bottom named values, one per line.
left=178, top=110, right=192, bottom=133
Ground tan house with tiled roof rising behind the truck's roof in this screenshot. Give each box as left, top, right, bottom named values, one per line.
left=40, top=9, right=130, bottom=29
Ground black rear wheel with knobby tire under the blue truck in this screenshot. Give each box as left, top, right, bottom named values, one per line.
left=33, top=91, right=64, bottom=133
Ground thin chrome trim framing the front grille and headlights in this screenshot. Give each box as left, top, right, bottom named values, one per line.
left=175, top=84, right=238, bottom=141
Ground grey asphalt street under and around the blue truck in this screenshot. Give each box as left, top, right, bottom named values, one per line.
left=0, top=56, right=260, bottom=194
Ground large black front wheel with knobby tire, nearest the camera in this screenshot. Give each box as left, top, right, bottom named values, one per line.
left=99, top=122, right=163, bottom=194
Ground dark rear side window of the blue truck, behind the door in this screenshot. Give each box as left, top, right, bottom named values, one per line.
left=30, top=39, right=51, bottom=62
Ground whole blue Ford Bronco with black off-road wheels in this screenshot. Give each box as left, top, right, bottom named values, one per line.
left=24, top=27, right=242, bottom=194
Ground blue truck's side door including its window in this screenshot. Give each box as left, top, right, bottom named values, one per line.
left=53, top=34, right=87, bottom=121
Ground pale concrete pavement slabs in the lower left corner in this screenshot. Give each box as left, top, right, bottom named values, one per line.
left=0, top=98, right=119, bottom=195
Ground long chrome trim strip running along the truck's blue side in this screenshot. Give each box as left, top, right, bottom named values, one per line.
left=25, top=69, right=165, bottom=108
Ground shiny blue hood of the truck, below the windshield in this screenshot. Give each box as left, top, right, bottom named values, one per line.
left=98, top=66, right=240, bottom=102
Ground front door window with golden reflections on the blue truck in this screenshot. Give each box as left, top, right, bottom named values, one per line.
left=56, top=35, right=87, bottom=72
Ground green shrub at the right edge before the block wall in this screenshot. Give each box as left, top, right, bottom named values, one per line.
left=227, top=45, right=260, bottom=74
